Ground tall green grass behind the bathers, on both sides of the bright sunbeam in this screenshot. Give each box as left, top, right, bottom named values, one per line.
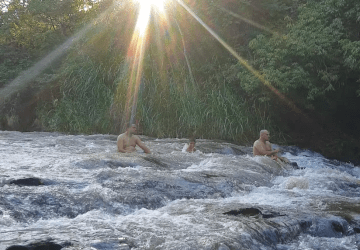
left=40, top=49, right=284, bottom=143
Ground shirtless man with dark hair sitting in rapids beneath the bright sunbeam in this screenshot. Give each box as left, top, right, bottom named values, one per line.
left=117, top=124, right=150, bottom=154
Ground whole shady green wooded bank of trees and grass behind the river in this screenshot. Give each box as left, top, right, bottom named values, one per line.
left=0, top=0, right=360, bottom=164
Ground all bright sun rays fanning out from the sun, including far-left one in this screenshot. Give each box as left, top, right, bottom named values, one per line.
left=0, top=0, right=306, bottom=128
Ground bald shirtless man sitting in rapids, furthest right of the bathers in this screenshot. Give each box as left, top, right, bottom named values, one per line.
left=253, top=130, right=290, bottom=164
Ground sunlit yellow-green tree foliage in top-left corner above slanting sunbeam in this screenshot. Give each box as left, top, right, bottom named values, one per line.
left=0, top=0, right=111, bottom=92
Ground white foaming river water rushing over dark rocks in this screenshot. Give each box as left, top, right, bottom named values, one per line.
left=0, top=131, right=360, bottom=250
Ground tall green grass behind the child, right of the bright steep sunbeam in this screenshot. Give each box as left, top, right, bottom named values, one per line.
left=138, top=66, right=277, bottom=143
